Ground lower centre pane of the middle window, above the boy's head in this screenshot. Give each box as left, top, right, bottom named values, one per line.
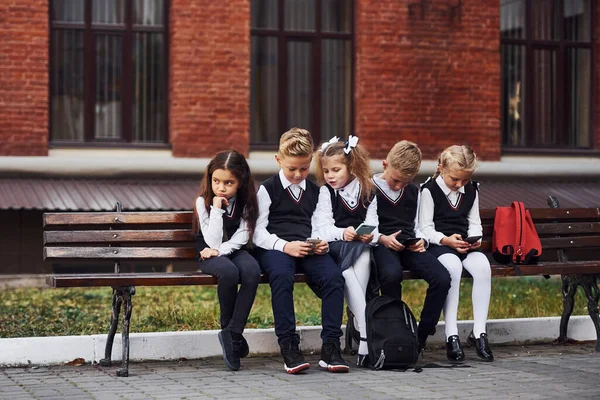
left=286, top=41, right=314, bottom=131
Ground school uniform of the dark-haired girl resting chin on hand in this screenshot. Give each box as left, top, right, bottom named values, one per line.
left=196, top=197, right=260, bottom=334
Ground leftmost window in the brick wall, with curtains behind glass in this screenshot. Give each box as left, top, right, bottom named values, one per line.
left=50, top=0, right=168, bottom=144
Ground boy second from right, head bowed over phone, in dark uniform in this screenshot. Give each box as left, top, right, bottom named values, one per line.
left=373, top=140, right=451, bottom=352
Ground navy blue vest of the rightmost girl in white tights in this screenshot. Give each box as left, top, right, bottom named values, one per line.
left=422, top=179, right=478, bottom=238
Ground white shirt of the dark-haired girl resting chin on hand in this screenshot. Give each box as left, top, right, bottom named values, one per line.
left=196, top=197, right=248, bottom=256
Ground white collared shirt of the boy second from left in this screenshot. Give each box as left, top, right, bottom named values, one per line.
left=252, top=170, right=315, bottom=251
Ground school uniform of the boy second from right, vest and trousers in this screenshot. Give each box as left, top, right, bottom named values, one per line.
left=373, top=174, right=450, bottom=337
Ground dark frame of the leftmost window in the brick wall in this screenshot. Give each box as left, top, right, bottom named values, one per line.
left=48, top=0, right=171, bottom=149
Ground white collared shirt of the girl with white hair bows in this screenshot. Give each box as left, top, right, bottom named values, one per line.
left=312, top=179, right=379, bottom=244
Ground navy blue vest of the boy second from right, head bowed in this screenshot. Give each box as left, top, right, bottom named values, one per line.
left=373, top=179, right=419, bottom=241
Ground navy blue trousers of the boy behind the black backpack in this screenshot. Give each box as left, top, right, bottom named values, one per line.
left=373, top=246, right=451, bottom=335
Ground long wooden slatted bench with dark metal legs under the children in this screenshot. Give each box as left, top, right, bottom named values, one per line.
left=43, top=198, right=600, bottom=376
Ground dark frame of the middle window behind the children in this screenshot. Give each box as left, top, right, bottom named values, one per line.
left=248, top=0, right=356, bottom=150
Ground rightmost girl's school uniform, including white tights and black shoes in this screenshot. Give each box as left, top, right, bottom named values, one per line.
left=419, top=176, right=493, bottom=361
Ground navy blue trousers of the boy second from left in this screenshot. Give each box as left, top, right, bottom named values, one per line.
left=258, top=249, right=344, bottom=343
